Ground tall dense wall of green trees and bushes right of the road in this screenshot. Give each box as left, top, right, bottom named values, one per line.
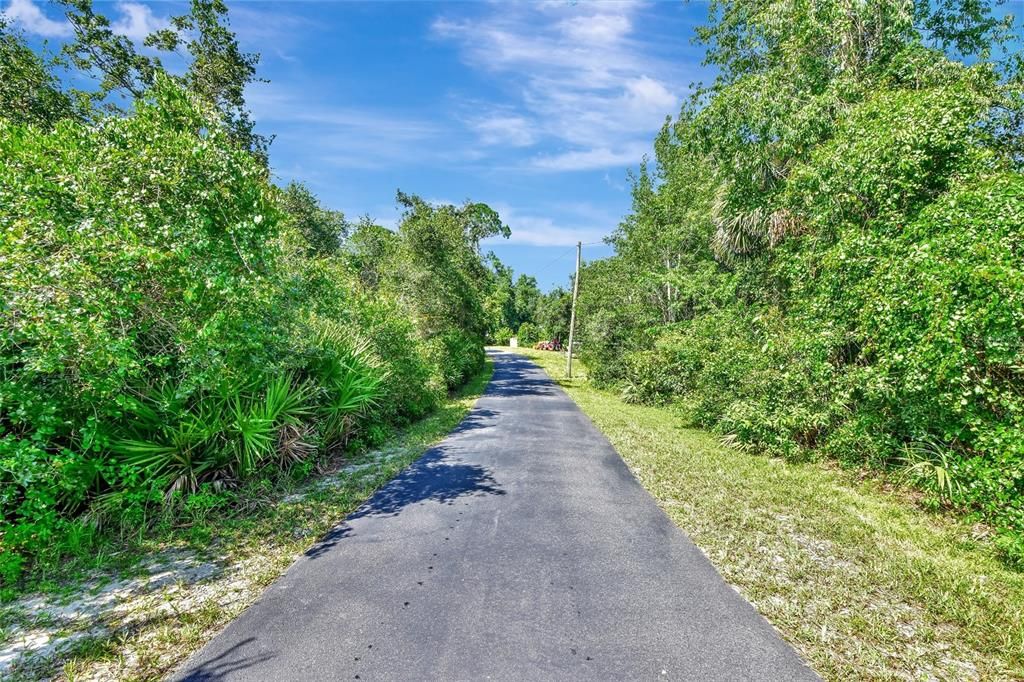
left=580, top=2, right=1024, bottom=561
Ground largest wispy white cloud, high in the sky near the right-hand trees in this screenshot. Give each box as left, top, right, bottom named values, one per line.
left=432, top=2, right=684, bottom=171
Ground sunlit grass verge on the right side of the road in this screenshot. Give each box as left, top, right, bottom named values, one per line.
left=518, top=349, right=1024, bottom=680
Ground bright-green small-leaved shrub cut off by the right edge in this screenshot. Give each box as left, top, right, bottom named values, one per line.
left=862, top=173, right=1024, bottom=481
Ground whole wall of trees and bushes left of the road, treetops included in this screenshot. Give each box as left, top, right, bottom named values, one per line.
left=0, top=0, right=544, bottom=590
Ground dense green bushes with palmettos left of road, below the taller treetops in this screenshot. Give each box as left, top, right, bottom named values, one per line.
left=0, top=79, right=497, bottom=583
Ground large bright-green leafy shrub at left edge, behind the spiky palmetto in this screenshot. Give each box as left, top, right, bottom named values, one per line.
left=0, top=82, right=287, bottom=577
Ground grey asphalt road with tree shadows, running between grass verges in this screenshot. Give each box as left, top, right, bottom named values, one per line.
left=175, top=352, right=817, bottom=681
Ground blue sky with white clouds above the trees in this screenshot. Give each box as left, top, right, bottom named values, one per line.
left=0, top=0, right=710, bottom=289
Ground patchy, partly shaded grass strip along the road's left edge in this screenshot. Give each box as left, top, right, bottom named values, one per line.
left=0, top=360, right=493, bottom=680
